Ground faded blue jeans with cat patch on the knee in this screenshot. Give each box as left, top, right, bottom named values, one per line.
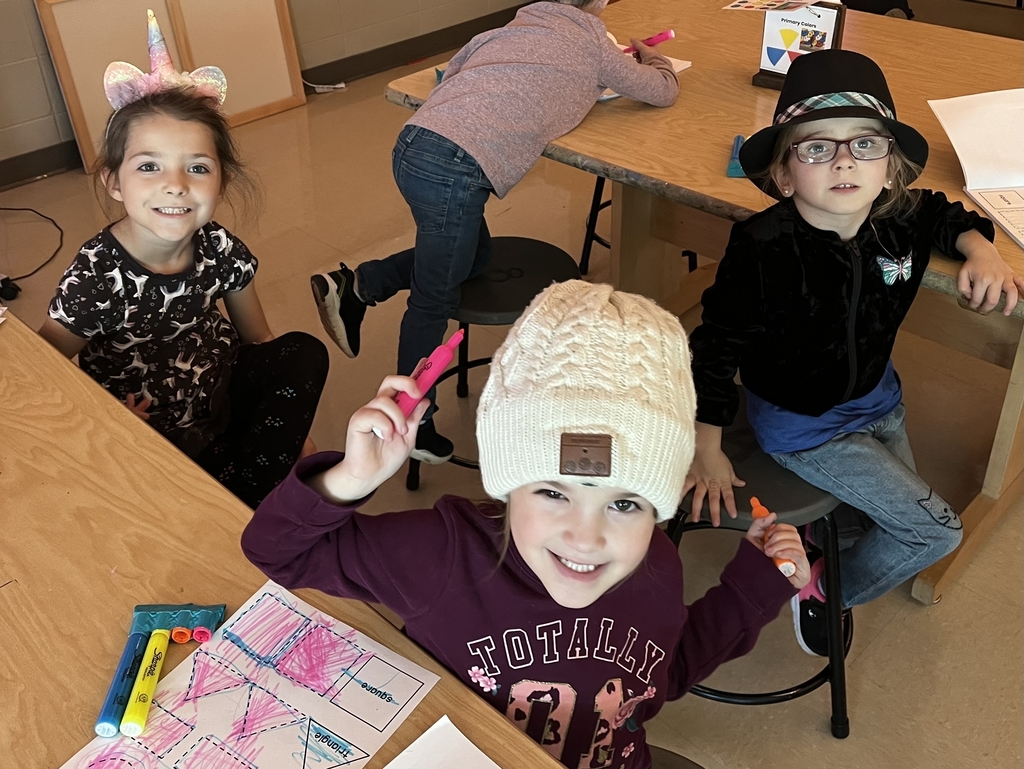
left=771, top=403, right=963, bottom=607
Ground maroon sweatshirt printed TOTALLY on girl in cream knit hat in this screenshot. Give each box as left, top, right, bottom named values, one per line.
left=242, top=453, right=796, bottom=769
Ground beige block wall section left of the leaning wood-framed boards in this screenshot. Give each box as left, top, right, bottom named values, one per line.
left=0, top=0, right=75, bottom=160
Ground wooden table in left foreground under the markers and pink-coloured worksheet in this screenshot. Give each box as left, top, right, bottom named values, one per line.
left=0, top=312, right=559, bottom=769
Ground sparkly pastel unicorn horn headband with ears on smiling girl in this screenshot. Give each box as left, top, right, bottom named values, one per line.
left=103, top=10, right=227, bottom=110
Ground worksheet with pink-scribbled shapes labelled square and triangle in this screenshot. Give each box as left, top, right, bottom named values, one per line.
left=65, top=582, right=438, bottom=769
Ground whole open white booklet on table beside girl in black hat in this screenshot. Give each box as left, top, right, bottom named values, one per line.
left=928, top=88, right=1024, bottom=248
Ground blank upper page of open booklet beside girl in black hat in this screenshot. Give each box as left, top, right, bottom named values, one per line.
left=928, top=88, right=1024, bottom=189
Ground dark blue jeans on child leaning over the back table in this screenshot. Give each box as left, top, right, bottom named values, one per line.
left=355, top=126, right=494, bottom=416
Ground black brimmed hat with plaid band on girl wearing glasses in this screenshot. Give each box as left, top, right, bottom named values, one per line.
left=739, top=49, right=928, bottom=198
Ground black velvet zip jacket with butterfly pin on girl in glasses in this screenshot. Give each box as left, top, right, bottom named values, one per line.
left=690, top=189, right=995, bottom=427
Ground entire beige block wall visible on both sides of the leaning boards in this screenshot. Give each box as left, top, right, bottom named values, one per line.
left=0, top=0, right=522, bottom=160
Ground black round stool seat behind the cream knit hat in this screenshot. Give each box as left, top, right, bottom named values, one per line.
left=455, top=238, right=580, bottom=326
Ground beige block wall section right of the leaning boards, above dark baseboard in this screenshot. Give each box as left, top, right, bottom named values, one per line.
left=288, top=0, right=524, bottom=70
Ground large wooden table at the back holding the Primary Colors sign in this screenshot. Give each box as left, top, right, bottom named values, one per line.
left=386, top=0, right=1024, bottom=603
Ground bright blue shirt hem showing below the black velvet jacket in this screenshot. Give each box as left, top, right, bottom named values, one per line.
left=743, top=360, right=903, bottom=454
